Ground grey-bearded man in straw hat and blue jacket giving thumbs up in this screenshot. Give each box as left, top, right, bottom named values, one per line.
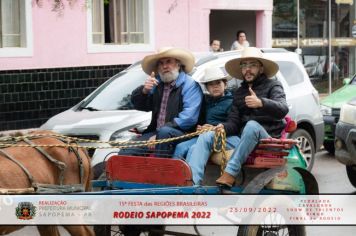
left=120, top=48, right=203, bottom=156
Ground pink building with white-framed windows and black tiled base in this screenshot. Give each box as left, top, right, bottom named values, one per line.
left=0, top=0, right=273, bottom=130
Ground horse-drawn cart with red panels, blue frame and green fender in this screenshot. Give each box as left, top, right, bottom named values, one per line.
left=93, top=124, right=318, bottom=236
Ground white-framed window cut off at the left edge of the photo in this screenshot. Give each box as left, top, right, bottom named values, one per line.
left=0, top=0, right=32, bottom=57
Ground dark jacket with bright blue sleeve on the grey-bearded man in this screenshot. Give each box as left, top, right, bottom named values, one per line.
left=131, top=72, right=203, bottom=133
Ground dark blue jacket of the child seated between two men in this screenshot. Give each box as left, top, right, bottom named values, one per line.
left=204, top=91, right=233, bottom=125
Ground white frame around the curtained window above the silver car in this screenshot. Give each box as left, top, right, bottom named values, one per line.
left=87, top=0, right=155, bottom=53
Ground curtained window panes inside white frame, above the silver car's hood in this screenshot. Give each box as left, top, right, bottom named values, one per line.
left=91, top=0, right=150, bottom=45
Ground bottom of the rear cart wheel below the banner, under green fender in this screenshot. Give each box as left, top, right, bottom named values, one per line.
left=237, top=225, right=306, bottom=236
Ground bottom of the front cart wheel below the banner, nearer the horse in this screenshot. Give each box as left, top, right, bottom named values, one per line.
left=94, top=225, right=165, bottom=236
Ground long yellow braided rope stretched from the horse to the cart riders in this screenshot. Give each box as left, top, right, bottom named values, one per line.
left=0, top=128, right=212, bottom=149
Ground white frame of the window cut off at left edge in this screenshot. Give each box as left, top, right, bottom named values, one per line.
left=0, top=0, right=33, bottom=57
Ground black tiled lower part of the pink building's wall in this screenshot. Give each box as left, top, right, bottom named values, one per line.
left=0, top=65, right=127, bottom=131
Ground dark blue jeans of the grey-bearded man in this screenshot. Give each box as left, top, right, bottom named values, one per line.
left=119, top=126, right=184, bottom=157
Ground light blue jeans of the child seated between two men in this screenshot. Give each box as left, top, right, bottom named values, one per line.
left=186, top=131, right=240, bottom=185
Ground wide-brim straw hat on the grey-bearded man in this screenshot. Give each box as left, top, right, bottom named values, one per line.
left=141, top=47, right=195, bottom=75
